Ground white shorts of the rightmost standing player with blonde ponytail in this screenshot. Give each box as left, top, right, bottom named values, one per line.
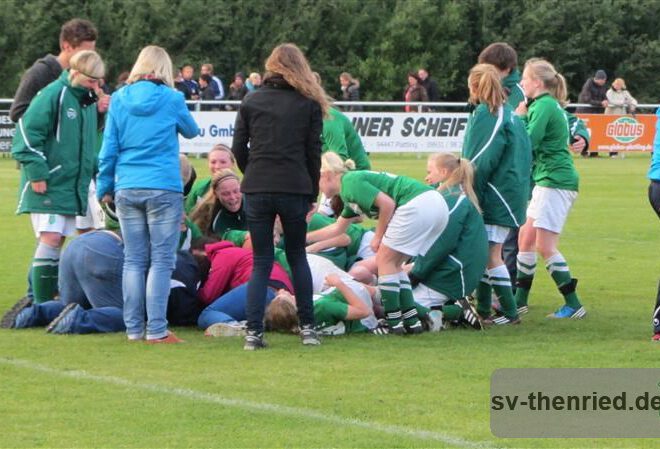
left=527, top=186, right=577, bottom=234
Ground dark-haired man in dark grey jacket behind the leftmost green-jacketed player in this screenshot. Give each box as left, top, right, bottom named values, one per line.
left=9, top=19, right=98, bottom=123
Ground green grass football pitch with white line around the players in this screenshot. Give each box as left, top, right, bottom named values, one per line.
left=0, top=155, right=660, bottom=448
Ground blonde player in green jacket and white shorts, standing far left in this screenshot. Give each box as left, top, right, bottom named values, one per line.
left=12, top=50, right=105, bottom=303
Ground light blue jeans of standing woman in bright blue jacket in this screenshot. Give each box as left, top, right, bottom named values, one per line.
left=115, top=189, right=183, bottom=339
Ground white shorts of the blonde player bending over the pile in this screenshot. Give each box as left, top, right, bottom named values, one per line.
left=382, top=190, right=449, bottom=256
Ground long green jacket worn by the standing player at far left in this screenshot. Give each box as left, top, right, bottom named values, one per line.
left=11, top=71, right=97, bottom=215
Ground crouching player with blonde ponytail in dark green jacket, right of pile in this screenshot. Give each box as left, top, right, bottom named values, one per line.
left=402, top=153, right=488, bottom=329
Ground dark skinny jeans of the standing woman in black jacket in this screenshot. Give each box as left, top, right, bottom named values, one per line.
left=245, top=193, right=314, bottom=332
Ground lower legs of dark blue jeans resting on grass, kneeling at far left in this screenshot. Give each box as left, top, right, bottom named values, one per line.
left=18, top=301, right=126, bottom=334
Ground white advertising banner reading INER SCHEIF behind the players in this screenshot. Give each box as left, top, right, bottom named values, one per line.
left=179, top=111, right=468, bottom=153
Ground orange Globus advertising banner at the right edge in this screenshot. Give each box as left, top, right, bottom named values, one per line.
left=577, top=114, right=656, bottom=152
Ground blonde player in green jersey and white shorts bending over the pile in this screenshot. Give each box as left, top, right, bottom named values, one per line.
left=319, top=152, right=448, bottom=335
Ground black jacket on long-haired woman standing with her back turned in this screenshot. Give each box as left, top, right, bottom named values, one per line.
left=232, top=76, right=323, bottom=201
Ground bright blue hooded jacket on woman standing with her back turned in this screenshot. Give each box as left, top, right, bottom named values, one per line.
left=96, top=80, right=199, bottom=199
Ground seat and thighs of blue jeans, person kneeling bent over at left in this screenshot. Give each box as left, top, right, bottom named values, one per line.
left=59, top=231, right=124, bottom=309
